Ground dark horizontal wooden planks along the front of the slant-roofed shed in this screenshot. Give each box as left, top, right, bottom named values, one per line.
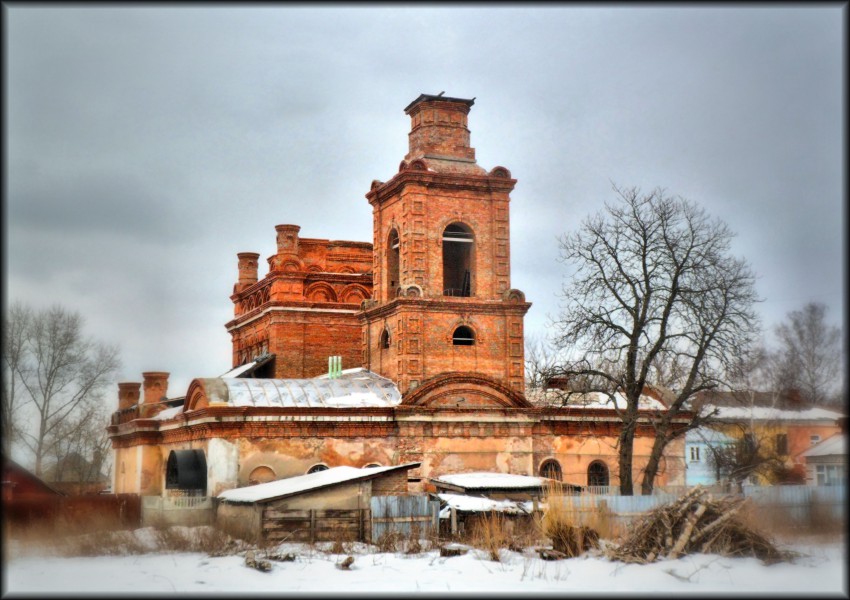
left=262, top=507, right=371, bottom=543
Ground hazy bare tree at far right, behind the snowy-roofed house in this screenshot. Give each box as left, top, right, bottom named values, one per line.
left=776, top=302, right=843, bottom=404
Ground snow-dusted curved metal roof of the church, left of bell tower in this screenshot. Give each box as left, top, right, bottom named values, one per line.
left=209, top=368, right=401, bottom=408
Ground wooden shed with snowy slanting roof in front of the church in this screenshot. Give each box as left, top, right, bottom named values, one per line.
left=216, top=463, right=420, bottom=543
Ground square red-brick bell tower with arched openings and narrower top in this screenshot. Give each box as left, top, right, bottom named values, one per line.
left=360, top=94, right=531, bottom=394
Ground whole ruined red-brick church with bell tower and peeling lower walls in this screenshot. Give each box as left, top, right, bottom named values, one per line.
left=110, top=94, right=682, bottom=495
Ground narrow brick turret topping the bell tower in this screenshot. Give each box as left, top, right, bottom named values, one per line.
left=404, top=92, right=475, bottom=162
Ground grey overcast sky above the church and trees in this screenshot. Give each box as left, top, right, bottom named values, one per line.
left=3, top=3, right=847, bottom=402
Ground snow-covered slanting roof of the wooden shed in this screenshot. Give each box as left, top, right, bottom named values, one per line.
left=218, top=463, right=419, bottom=503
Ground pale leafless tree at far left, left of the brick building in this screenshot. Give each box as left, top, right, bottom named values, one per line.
left=3, top=304, right=119, bottom=476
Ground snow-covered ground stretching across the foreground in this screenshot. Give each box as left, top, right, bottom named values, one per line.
left=4, top=528, right=848, bottom=597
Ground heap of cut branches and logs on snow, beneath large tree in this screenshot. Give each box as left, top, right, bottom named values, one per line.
left=608, top=486, right=793, bottom=564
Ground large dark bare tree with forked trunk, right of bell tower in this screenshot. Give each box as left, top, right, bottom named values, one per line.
left=555, top=187, right=759, bottom=495
